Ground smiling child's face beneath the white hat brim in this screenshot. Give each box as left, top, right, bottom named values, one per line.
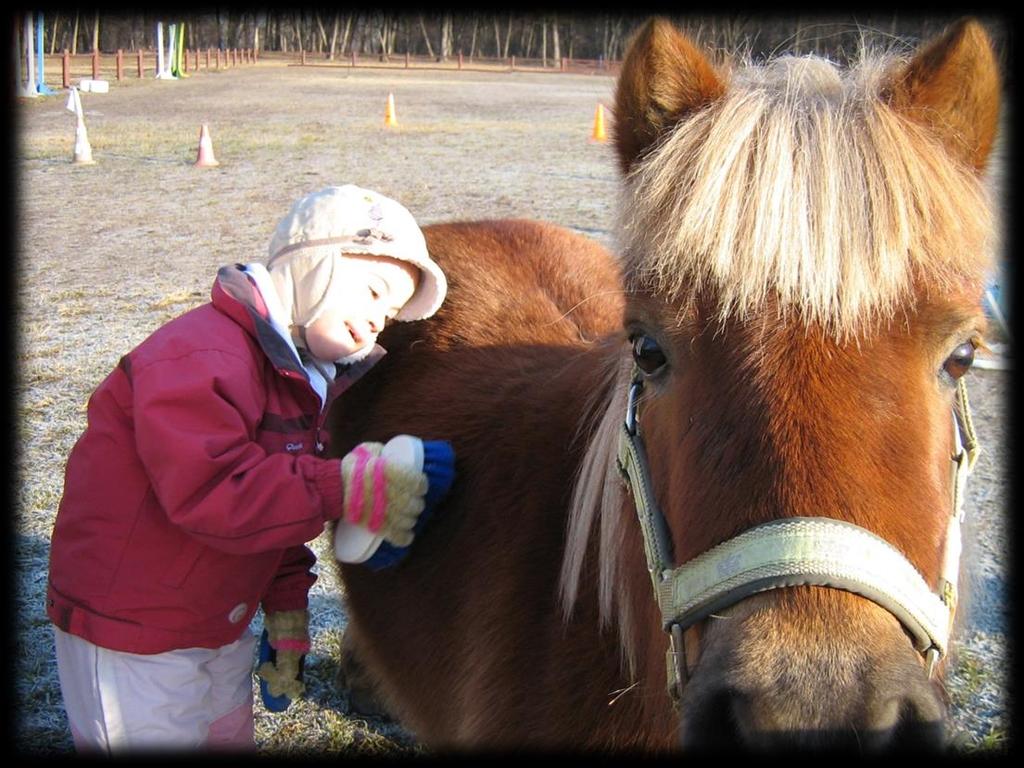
left=305, top=255, right=420, bottom=360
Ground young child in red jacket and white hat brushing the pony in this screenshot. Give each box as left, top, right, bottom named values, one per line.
left=47, top=185, right=446, bottom=752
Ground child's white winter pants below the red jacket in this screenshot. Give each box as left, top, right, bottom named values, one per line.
left=54, top=628, right=256, bottom=753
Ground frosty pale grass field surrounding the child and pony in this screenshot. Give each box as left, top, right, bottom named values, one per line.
left=14, top=57, right=1012, bottom=753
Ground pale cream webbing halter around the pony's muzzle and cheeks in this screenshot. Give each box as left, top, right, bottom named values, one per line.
left=617, top=370, right=980, bottom=703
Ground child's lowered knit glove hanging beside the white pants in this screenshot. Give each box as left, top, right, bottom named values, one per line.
left=256, top=609, right=309, bottom=712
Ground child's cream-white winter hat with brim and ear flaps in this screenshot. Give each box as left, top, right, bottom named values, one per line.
left=266, top=184, right=447, bottom=325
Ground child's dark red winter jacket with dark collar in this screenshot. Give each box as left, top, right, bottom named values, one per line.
left=46, top=266, right=383, bottom=653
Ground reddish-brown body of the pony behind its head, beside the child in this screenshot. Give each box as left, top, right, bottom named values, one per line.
left=332, top=221, right=623, bottom=745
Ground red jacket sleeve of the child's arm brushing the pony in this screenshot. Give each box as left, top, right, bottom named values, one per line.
left=131, top=350, right=422, bottom=554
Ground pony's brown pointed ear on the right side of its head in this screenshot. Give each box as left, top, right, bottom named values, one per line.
left=885, top=18, right=999, bottom=171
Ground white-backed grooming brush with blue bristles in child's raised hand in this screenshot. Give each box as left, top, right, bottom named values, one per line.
left=334, top=434, right=455, bottom=570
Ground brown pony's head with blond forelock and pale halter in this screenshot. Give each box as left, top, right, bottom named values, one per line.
left=562, top=20, right=999, bottom=748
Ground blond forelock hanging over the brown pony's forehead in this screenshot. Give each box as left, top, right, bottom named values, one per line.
left=618, top=46, right=992, bottom=338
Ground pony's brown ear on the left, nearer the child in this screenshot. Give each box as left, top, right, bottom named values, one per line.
left=612, top=18, right=725, bottom=173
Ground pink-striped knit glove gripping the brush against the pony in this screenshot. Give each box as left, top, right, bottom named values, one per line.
left=341, top=442, right=428, bottom=547
